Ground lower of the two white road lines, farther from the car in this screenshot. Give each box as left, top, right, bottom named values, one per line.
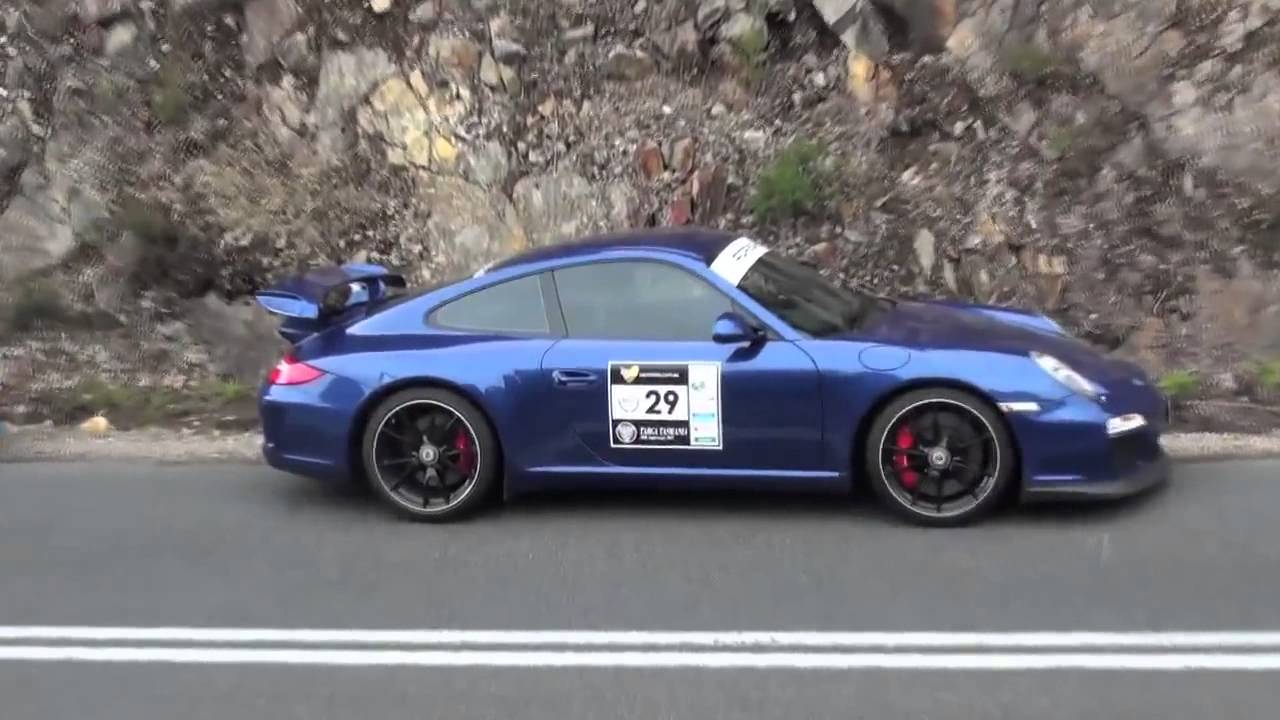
left=0, top=646, right=1280, bottom=671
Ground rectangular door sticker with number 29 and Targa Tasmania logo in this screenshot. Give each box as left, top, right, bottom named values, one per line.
left=609, top=363, right=721, bottom=450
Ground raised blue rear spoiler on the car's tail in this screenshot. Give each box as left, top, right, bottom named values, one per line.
left=253, top=263, right=404, bottom=342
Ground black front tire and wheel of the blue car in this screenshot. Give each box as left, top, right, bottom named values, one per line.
left=863, top=387, right=1018, bottom=527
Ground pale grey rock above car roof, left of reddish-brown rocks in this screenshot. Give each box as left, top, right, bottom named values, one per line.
left=511, top=173, right=637, bottom=246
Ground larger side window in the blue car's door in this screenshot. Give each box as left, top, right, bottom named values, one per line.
left=554, top=261, right=732, bottom=341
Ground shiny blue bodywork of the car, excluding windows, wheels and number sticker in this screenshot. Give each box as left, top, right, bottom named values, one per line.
left=260, top=229, right=1166, bottom=496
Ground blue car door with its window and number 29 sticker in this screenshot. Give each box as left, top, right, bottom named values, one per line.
left=543, top=259, right=822, bottom=475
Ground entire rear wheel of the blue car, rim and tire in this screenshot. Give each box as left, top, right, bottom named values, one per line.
left=362, top=388, right=499, bottom=523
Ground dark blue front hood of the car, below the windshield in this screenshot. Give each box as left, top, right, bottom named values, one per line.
left=858, top=300, right=1147, bottom=387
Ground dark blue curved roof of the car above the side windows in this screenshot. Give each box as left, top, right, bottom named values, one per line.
left=489, top=227, right=740, bottom=270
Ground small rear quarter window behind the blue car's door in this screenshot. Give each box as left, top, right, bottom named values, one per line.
left=430, top=275, right=550, bottom=334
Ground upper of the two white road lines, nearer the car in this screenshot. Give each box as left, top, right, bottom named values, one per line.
left=0, top=625, right=1280, bottom=651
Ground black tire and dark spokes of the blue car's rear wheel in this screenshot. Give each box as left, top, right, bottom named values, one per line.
left=361, top=387, right=502, bottom=523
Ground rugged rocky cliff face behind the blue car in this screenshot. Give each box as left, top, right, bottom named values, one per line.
left=0, top=0, right=1280, bottom=424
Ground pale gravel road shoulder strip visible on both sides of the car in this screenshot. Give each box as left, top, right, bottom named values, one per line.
left=0, top=427, right=1280, bottom=462
